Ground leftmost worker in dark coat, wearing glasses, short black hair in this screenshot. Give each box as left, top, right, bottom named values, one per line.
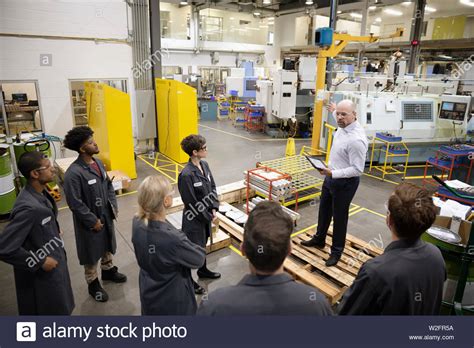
left=0, top=151, right=74, bottom=315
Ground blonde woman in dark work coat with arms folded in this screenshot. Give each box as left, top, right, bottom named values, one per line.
left=132, top=175, right=205, bottom=315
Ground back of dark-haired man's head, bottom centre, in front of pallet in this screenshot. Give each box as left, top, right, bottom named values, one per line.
left=242, top=201, right=293, bottom=273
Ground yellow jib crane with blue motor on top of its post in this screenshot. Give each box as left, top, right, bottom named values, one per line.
left=311, top=28, right=404, bottom=151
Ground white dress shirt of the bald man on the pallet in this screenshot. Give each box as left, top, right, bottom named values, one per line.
left=328, top=121, right=368, bottom=179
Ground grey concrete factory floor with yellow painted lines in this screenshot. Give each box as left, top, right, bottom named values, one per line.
left=0, top=121, right=474, bottom=315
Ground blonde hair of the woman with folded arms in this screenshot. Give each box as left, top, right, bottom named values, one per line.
left=136, top=175, right=173, bottom=224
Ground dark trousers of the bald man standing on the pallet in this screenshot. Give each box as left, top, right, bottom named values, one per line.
left=314, top=177, right=360, bottom=256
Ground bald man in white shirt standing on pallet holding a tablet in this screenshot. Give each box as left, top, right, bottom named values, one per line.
left=301, top=100, right=368, bottom=266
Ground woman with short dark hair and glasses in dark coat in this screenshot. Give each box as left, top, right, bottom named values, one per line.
left=178, top=134, right=221, bottom=294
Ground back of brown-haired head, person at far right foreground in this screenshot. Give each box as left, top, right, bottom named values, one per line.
left=388, top=183, right=436, bottom=240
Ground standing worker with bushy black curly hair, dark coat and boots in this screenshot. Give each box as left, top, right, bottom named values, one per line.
left=64, top=126, right=127, bottom=302
